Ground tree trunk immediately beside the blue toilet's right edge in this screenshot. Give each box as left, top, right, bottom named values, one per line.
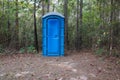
left=64, top=0, right=69, bottom=50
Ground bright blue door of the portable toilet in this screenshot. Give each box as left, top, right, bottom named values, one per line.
left=47, top=18, right=60, bottom=54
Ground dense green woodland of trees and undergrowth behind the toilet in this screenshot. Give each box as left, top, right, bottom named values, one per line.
left=0, top=0, right=120, bottom=57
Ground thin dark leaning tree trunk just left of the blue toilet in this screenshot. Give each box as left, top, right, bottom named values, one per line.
left=34, top=0, right=39, bottom=52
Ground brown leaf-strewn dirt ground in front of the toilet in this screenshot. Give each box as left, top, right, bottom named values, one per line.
left=0, top=51, right=120, bottom=80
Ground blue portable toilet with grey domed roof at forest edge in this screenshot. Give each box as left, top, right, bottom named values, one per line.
left=42, top=12, right=64, bottom=56
